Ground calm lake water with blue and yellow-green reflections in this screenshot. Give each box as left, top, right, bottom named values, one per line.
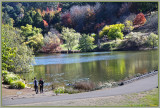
left=19, top=50, right=158, bottom=88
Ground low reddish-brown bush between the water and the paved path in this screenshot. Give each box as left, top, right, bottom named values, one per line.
left=74, top=82, right=95, bottom=91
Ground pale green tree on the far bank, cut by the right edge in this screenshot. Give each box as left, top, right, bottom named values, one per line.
left=147, top=33, right=158, bottom=48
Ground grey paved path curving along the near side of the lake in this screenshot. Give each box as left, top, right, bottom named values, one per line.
left=2, top=74, right=158, bottom=106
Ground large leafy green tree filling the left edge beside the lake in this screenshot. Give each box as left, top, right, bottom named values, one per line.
left=1, top=24, right=34, bottom=72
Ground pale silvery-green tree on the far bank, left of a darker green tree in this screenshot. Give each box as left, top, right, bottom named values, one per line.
left=62, top=28, right=81, bottom=51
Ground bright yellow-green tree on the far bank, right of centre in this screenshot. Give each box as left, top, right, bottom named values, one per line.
left=99, top=24, right=125, bottom=41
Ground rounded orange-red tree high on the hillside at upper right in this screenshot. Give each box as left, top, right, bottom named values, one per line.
left=133, top=13, right=146, bottom=25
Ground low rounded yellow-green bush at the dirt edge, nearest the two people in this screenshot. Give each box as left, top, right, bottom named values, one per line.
left=9, top=80, right=25, bottom=89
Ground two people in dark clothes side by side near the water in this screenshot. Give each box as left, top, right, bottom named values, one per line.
left=33, top=77, right=44, bottom=94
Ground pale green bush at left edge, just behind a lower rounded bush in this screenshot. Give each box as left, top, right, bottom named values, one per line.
left=4, top=73, right=20, bottom=84
